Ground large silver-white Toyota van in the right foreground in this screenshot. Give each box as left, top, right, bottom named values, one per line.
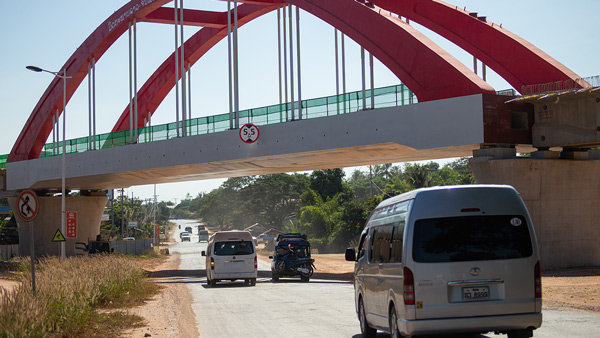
left=346, top=185, right=542, bottom=338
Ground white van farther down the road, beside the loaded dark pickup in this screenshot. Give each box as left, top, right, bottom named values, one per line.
left=202, top=231, right=258, bottom=286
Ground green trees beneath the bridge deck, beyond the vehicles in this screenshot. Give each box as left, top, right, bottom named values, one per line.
left=171, top=158, right=475, bottom=253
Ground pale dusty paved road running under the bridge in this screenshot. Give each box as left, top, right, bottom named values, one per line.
left=172, top=221, right=600, bottom=338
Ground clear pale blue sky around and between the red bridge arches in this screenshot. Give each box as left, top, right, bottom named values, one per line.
left=0, top=0, right=600, bottom=201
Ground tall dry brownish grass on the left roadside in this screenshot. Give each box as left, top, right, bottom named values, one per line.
left=0, top=255, right=158, bottom=338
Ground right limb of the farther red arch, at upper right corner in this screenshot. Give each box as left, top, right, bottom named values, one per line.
left=372, top=0, right=580, bottom=90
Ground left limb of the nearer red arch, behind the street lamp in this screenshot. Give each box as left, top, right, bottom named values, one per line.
left=7, top=0, right=171, bottom=162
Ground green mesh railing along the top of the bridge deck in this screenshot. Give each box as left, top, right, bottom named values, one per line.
left=0, top=84, right=417, bottom=168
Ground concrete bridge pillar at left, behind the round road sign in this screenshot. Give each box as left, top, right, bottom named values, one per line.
left=8, top=194, right=108, bottom=257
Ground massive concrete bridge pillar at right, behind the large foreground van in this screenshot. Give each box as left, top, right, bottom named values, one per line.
left=470, top=149, right=600, bottom=270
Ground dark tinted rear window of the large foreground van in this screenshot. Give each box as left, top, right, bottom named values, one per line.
left=413, top=215, right=533, bottom=263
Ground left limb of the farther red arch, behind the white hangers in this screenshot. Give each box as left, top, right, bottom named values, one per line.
left=112, top=4, right=280, bottom=132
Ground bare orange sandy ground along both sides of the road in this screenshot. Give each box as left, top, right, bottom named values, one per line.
left=0, top=250, right=600, bottom=338
